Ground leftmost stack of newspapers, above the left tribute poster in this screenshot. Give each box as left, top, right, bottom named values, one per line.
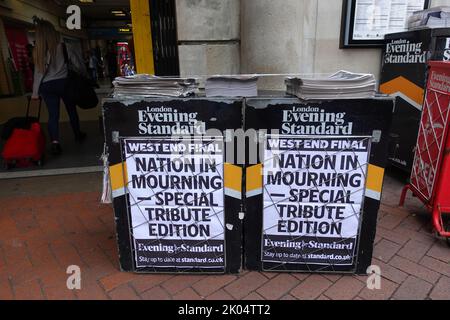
left=113, top=74, right=198, bottom=98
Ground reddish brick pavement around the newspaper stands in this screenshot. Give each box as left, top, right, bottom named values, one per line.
left=0, top=172, right=450, bottom=300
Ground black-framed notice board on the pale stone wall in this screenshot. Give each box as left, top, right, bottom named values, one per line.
left=340, top=0, right=430, bottom=49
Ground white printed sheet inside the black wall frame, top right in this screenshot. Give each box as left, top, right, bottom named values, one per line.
left=353, top=0, right=426, bottom=40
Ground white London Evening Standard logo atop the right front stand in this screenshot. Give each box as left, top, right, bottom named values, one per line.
left=281, top=107, right=353, bottom=135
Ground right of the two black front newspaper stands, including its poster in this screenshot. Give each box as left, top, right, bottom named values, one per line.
left=244, top=98, right=393, bottom=274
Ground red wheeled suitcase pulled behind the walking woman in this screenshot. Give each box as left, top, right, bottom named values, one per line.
left=2, top=97, right=45, bottom=169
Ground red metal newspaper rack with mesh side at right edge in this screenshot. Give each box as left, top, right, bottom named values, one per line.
left=400, top=61, right=450, bottom=243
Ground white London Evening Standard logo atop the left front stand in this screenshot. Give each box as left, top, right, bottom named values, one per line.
left=138, top=107, right=206, bottom=135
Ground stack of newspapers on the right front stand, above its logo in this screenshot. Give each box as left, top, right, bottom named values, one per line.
left=285, top=70, right=377, bottom=100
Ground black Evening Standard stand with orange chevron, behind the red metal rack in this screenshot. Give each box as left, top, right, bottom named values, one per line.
left=380, top=28, right=450, bottom=172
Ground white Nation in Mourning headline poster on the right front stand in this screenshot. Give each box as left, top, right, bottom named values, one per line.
left=262, top=135, right=370, bottom=266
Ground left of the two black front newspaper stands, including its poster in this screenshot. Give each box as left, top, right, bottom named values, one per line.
left=103, top=98, right=243, bottom=273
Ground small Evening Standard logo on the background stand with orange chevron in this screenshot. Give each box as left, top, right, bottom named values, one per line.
left=384, top=39, right=427, bottom=64
